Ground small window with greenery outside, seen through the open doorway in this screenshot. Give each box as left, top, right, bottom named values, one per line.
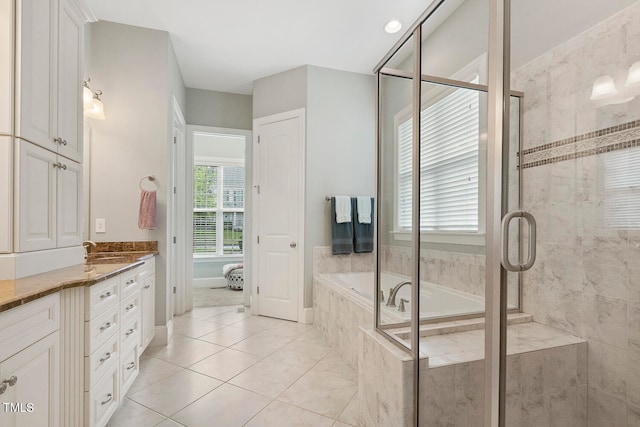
left=193, top=160, right=244, bottom=255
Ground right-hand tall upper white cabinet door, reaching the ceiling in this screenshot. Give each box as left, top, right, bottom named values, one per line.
left=57, top=0, right=84, bottom=162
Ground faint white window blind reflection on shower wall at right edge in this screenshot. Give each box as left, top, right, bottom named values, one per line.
left=604, top=148, right=640, bottom=228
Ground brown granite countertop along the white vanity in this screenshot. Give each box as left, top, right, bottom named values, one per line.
left=0, top=251, right=158, bottom=312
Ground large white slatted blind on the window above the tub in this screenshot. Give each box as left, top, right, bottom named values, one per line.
left=397, top=75, right=480, bottom=232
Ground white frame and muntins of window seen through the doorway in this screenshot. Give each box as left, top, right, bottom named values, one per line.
left=191, top=156, right=247, bottom=259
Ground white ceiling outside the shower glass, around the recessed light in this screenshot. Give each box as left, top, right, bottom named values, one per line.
left=88, top=0, right=431, bottom=94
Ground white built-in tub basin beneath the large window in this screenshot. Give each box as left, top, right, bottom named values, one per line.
left=320, top=272, right=484, bottom=323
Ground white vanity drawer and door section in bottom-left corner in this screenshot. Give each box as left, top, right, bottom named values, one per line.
left=0, top=293, right=60, bottom=427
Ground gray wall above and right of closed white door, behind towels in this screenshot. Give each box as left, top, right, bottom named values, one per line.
left=253, top=66, right=375, bottom=307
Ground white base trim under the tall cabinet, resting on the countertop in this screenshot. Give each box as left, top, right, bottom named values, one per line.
left=0, top=246, right=84, bottom=280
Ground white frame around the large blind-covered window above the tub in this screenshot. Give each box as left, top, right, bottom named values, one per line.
left=390, top=53, right=487, bottom=246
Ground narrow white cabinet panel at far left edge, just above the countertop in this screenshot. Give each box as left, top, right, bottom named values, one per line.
left=0, top=136, right=13, bottom=253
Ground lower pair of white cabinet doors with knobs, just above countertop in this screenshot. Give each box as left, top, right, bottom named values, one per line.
left=13, top=140, right=82, bottom=252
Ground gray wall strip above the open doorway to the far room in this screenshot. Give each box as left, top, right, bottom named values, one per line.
left=185, top=88, right=253, bottom=129
